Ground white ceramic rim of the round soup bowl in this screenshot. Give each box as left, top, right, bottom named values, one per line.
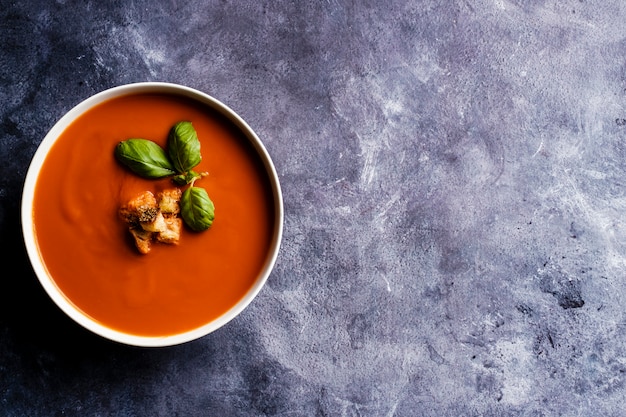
left=21, top=81, right=284, bottom=347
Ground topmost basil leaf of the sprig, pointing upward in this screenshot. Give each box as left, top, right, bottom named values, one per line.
left=167, top=121, right=202, bottom=174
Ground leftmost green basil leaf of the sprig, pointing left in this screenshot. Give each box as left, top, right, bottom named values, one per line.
left=115, top=139, right=176, bottom=179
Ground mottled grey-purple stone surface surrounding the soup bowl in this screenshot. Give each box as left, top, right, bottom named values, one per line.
left=0, top=0, right=626, bottom=417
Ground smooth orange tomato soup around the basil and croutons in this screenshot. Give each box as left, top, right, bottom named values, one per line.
left=33, top=94, right=274, bottom=336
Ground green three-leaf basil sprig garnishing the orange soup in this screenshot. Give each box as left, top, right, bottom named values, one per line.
left=115, top=121, right=215, bottom=232
